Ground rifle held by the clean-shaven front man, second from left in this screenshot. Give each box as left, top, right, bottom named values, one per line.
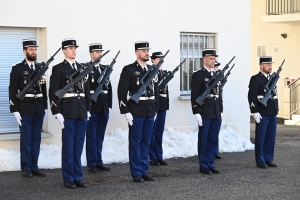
left=55, top=50, right=109, bottom=99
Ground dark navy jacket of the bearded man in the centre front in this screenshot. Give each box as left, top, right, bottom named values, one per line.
left=118, top=61, right=159, bottom=117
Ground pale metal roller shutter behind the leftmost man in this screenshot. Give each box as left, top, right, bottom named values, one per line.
left=0, top=27, right=37, bottom=134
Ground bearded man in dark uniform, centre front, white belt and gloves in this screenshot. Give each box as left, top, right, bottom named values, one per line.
left=118, top=42, right=158, bottom=183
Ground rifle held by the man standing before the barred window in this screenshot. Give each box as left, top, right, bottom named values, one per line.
left=196, top=56, right=235, bottom=105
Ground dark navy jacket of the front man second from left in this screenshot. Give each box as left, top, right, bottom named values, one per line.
left=49, top=60, right=91, bottom=119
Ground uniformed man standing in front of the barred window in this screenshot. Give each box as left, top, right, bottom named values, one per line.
left=191, top=49, right=223, bottom=174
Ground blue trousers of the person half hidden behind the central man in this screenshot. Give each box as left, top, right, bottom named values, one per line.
left=149, top=110, right=167, bottom=160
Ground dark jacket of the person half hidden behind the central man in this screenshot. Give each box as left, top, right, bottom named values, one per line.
left=158, top=70, right=169, bottom=110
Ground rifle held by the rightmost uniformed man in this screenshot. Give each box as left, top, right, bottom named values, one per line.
left=258, top=59, right=285, bottom=107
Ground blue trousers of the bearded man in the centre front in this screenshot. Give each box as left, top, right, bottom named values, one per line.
left=129, top=116, right=154, bottom=177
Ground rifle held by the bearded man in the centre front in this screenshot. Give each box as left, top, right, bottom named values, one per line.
left=131, top=50, right=170, bottom=104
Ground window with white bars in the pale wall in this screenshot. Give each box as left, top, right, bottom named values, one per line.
left=180, top=33, right=216, bottom=96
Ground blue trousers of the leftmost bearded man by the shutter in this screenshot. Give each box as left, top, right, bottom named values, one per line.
left=20, top=108, right=44, bottom=171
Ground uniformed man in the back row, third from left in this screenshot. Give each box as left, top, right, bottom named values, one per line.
left=86, top=43, right=112, bottom=173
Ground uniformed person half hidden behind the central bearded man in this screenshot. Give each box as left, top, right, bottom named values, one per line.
left=149, top=52, right=169, bottom=165
